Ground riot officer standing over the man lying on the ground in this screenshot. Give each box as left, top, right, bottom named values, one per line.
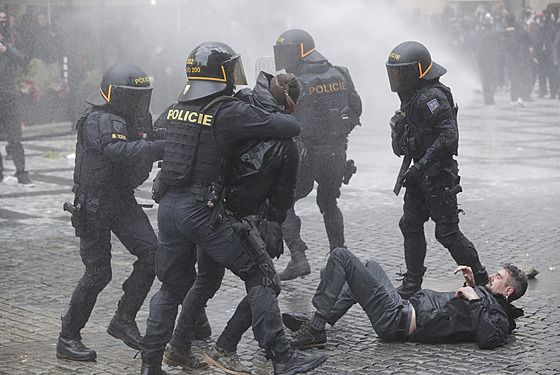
left=386, top=41, right=488, bottom=299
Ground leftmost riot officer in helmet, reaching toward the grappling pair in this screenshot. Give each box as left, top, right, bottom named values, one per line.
left=56, top=63, right=164, bottom=361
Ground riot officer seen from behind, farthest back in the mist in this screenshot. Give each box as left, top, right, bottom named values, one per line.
left=274, top=29, right=362, bottom=280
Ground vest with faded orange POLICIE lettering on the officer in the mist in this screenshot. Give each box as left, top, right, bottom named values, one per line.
left=294, top=64, right=355, bottom=145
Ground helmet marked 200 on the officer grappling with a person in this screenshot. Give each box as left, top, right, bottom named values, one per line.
left=177, top=42, right=247, bottom=102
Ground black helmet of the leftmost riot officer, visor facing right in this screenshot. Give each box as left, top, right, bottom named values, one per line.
left=86, top=63, right=152, bottom=118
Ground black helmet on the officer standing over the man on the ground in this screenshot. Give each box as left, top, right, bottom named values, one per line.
left=385, top=41, right=447, bottom=92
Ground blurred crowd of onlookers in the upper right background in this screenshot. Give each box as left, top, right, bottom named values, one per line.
left=414, top=6, right=560, bottom=106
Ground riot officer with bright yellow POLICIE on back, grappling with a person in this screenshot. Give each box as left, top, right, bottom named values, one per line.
left=140, top=42, right=325, bottom=375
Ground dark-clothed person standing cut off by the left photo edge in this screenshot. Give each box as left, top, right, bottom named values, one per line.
left=0, top=9, right=31, bottom=184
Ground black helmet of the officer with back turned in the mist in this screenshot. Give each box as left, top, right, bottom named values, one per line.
left=273, top=29, right=326, bottom=71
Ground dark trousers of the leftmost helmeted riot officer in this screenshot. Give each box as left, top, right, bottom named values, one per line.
left=62, top=195, right=157, bottom=337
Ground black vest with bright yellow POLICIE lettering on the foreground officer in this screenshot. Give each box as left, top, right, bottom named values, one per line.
left=161, top=102, right=223, bottom=186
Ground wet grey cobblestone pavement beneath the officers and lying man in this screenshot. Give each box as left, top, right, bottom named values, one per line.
left=0, top=93, right=560, bottom=375
